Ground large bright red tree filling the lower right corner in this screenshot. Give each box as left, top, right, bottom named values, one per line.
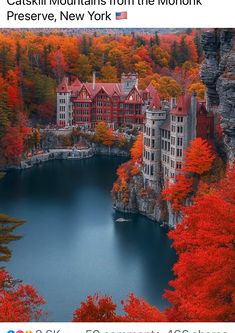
left=165, top=168, right=235, bottom=321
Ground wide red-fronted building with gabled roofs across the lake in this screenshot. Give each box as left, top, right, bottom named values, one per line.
left=56, top=73, right=157, bottom=128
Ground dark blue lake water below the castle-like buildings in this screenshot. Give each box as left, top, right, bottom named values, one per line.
left=0, top=157, right=176, bottom=321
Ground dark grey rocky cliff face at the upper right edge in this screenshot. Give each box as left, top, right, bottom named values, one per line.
left=201, top=29, right=235, bottom=160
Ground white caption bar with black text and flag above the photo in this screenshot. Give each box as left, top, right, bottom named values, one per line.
left=0, top=0, right=235, bottom=28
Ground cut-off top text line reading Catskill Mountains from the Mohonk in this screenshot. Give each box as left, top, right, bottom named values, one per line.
left=7, top=0, right=205, bottom=6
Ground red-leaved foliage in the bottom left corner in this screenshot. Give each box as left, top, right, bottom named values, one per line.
left=0, top=269, right=45, bottom=322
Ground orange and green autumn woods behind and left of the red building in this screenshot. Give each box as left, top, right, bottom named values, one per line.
left=0, top=30, right=204, bottom=163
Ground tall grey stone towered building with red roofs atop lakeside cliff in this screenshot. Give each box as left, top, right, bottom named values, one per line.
left=143, top=94, right=214, bottom=191
